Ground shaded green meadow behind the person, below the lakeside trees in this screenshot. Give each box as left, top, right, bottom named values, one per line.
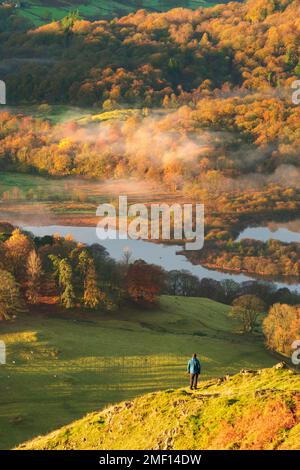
left=0, top=297, right=274, bottom=449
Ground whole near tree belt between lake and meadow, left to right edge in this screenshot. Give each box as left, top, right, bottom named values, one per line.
left=0, top=223, right=300, bottom=360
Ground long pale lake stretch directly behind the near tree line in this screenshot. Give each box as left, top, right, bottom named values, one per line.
left=23, top=225, right=300, bottom=290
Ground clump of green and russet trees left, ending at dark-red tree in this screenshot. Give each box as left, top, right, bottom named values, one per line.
left=0, top=224, right=164, bottom=319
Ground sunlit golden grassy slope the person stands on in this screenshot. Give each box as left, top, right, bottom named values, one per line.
left=17, top=368, right=300, bottom=450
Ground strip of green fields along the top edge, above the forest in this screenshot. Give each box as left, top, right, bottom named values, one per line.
left=11, top=0, right=220, bottom=25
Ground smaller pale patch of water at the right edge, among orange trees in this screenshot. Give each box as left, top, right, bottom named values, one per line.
left=237, top=219, right=300, bottom=243
